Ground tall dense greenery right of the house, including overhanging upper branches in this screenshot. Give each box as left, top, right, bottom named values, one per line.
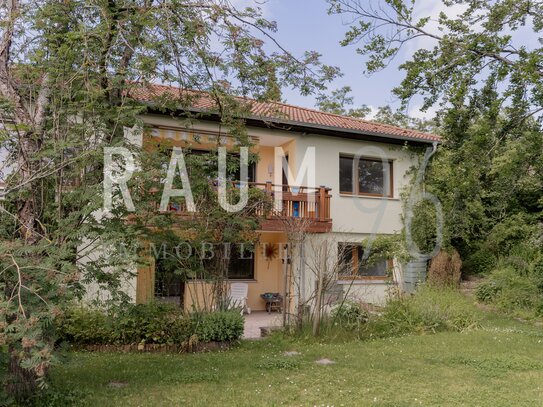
left=329, top=0, right=543, bottom=271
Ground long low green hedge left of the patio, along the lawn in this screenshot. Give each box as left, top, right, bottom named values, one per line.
left=56, top=303, right=244, bottom=345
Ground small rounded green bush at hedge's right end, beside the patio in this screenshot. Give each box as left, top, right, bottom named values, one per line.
left=192, top=311, right=244, bottom=342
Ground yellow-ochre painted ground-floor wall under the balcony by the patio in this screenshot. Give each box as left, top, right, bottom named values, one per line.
left=185, top=232, right=286, bottom=311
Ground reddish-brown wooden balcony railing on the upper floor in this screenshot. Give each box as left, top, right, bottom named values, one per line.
left=163, top=182, right=332, bottom=233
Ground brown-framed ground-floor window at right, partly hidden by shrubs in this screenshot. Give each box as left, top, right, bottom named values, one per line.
left=338, top=243, right=390, bottom=279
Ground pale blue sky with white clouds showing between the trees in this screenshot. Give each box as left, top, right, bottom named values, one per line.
left=245, top=0, right=540, bottom=118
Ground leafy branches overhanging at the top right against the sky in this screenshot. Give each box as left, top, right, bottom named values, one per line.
left=328, top=0, right=543, bottom=122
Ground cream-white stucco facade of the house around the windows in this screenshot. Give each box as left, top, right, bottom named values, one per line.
left=82, top=114, right=430, bottom=304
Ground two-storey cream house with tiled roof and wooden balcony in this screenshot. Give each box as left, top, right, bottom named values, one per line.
left=86, top=85, right=439, bottom=310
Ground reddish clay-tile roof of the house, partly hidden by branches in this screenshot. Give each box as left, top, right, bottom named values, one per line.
left=129, top=84, right=441, bottom=142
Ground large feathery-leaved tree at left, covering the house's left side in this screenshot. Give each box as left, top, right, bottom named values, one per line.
left=0, top=0, right=337, bottom=400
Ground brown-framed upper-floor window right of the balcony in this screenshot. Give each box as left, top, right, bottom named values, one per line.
left=339, top=156, right=394, bottom=197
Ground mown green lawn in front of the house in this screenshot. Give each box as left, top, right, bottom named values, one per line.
left=44, top=318, right=543, bottom=406
